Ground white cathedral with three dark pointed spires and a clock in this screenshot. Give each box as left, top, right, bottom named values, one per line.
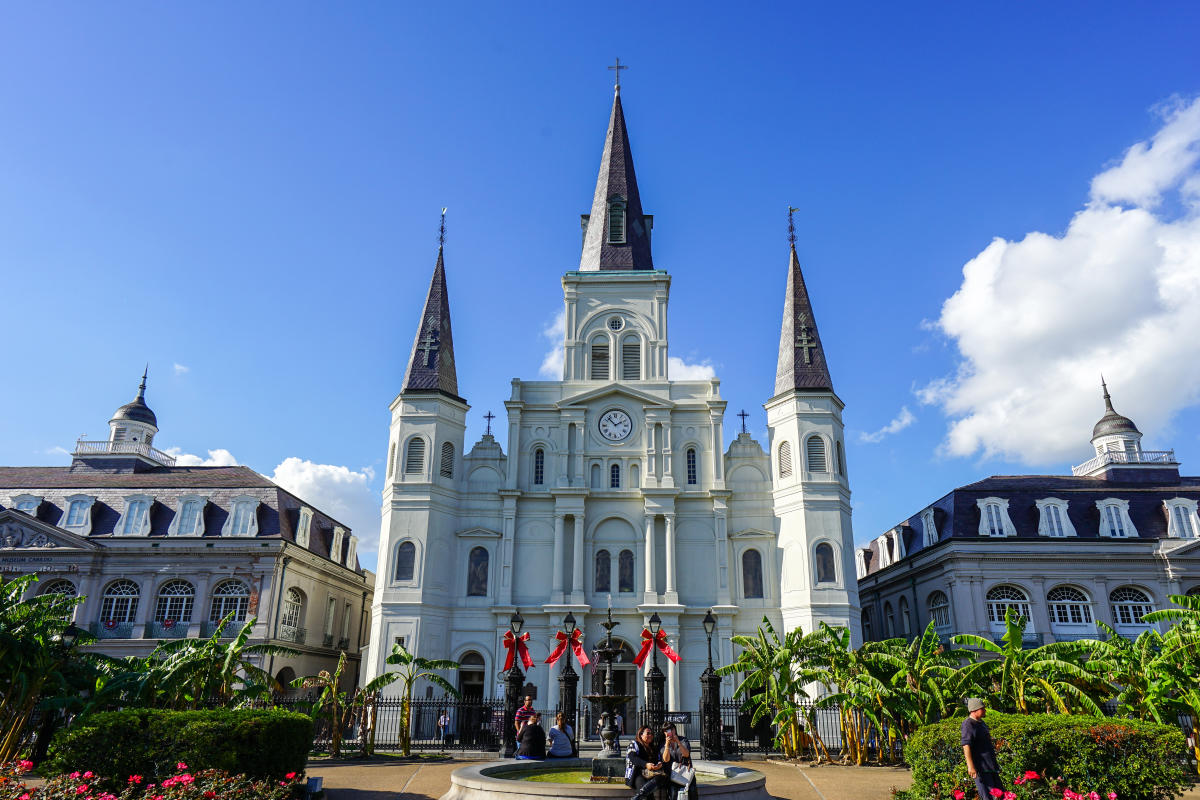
left=366, top=88, right=860, bottom=710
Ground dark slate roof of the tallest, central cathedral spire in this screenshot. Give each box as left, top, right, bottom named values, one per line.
left=580, top=86, right=654, bottom=271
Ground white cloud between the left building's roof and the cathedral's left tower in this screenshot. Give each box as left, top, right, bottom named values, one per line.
left=270, top=456, right=379, bottom=569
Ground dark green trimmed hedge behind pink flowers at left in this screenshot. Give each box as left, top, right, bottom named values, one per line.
left=42, top=709, right=313, bottom=780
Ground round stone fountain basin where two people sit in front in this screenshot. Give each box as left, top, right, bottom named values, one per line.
left=440, top=758, right=770, bottom=800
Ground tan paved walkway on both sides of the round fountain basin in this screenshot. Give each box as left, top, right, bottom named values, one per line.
left=308, top=760, right=910, bottom=800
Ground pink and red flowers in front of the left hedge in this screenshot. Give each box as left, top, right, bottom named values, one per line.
left=0, top=762, right=305, bottom=800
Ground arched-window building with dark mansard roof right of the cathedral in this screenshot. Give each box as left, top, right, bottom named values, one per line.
left=856, top=386, right=1200, bottom=643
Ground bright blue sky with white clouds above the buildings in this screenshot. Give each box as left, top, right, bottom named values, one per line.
left=0, top=2, right=1200, bottom=573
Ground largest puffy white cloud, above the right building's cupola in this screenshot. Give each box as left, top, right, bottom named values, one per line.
left=917, top=98, right=1200, bottom=464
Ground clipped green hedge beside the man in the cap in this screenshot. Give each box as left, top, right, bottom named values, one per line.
left=902, top=711, right=1192, bottom=800
